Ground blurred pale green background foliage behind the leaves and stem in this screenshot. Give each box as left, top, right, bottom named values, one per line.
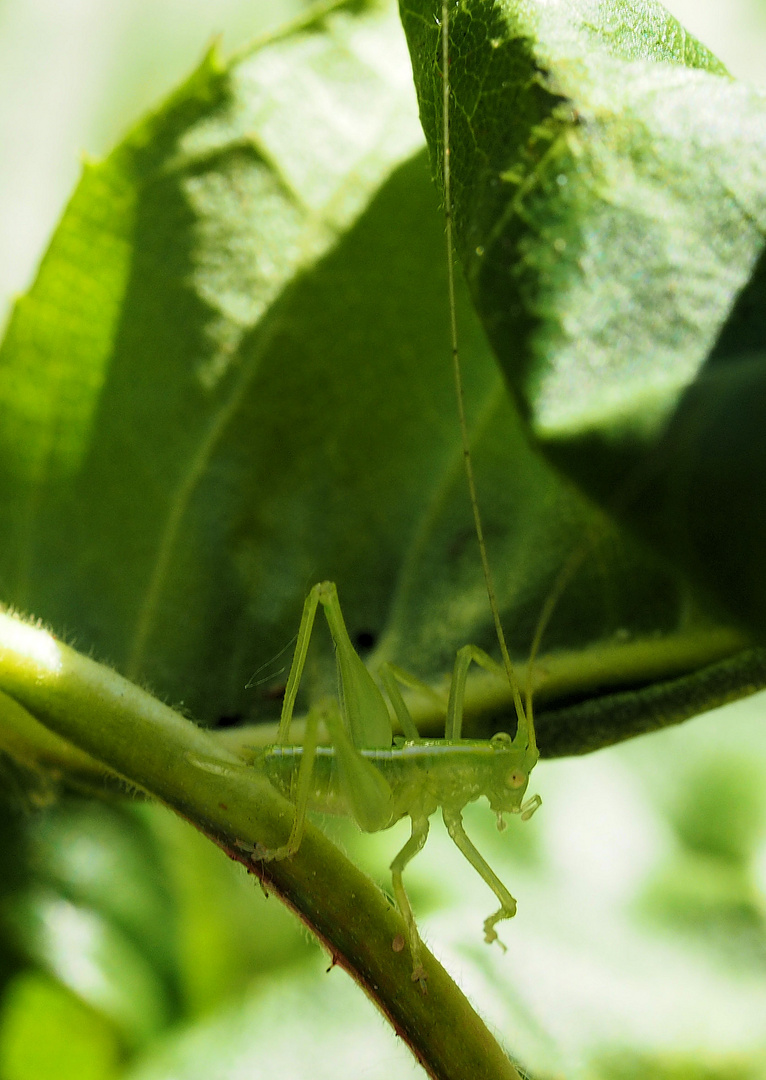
left=0, top=0, right=766, bottom=1080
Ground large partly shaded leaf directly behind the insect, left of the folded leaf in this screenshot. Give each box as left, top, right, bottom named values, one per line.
left=0, top=3, right=761, bottom=753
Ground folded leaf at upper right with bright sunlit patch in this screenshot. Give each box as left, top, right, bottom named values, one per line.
left=402, top=0, right=766, bottom=634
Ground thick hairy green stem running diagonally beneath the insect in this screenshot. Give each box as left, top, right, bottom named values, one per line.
left=0, top=613, right=520, bottom=1080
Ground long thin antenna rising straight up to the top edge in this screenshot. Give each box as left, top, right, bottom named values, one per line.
left=442, top=0, right=537, bottom=751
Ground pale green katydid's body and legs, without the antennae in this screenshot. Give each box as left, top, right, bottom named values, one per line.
left=254, top=581, right=540, bottom=984
